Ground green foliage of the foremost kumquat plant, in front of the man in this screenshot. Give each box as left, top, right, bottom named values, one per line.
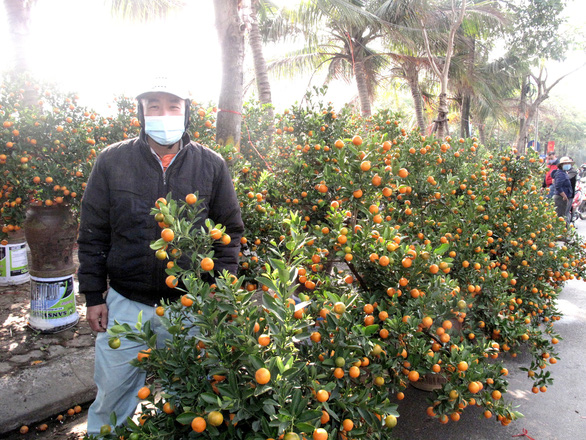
left=90, top=199, right=397, bottom=439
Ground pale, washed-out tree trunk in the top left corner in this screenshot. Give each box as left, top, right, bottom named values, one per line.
left=4, top=0, right=34, bottom=73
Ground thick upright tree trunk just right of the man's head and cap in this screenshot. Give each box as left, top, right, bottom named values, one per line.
left=214, top=0, right=245, bottom=150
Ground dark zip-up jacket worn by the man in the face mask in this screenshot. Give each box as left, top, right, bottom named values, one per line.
left=78, top=131, right=244, bottom=306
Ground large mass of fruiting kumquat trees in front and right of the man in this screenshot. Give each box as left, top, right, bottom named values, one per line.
left=83, top=89, right=586, bottom=440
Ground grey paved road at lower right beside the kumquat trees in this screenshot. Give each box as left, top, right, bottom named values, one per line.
left=388, top=221, right=586, bottom=440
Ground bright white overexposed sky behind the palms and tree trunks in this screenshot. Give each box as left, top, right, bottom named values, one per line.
left=0, top=0, right=586, bottom=112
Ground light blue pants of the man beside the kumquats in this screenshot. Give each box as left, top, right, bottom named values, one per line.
left=87, top=288, right=171, bottom=434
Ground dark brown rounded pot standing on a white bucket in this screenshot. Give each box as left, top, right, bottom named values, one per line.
left=24, top=205, right=78, bottom=278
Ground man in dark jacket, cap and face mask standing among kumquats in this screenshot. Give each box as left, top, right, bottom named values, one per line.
left=78, top=78, right=244, bottom=434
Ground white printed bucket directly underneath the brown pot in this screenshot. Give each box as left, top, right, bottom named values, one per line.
left=28, top=275, right=79, bottom=333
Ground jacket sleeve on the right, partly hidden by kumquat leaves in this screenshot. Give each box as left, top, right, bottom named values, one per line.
left=209, top=160, right=244, bottom=275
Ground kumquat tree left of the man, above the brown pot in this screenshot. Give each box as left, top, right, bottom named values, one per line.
left=0, top=75, right=139, bottom=238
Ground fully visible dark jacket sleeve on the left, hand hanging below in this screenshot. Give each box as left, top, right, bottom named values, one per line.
left=77, top=153, right=111, bottom=306
